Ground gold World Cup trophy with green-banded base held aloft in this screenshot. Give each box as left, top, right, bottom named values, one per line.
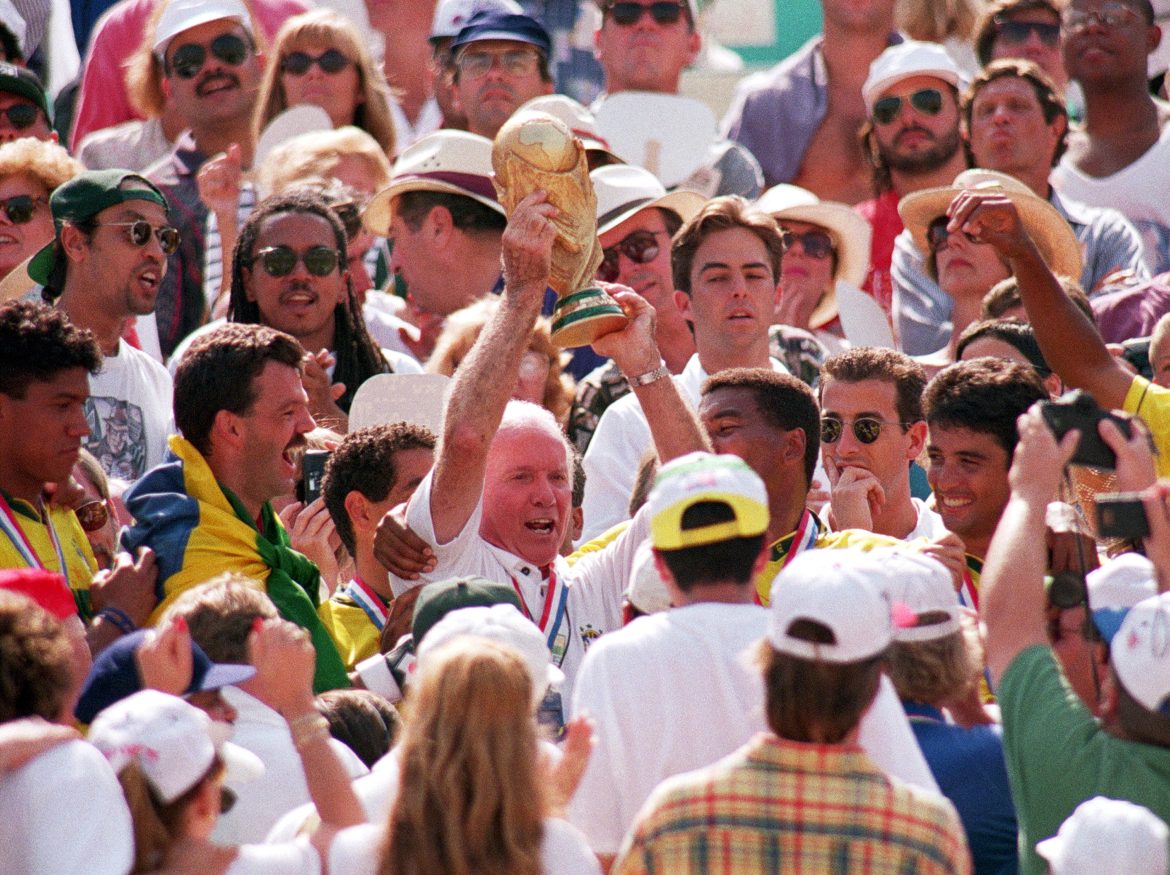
left=491, top=110, right=629, bottom=346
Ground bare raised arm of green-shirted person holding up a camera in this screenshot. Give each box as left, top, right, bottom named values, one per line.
left=979, top=406, right=1080, bottom=683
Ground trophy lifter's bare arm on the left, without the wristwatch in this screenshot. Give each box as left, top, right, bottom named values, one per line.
left=431, top=192, right=557, bottom=544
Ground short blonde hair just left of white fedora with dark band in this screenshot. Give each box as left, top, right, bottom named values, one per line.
left=257, top=125, right=391, bottom=197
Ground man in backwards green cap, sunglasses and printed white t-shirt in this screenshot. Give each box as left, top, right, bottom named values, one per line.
left=35, top=170, right=179, bottom=483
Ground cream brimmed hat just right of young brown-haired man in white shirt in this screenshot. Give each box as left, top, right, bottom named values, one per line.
left=756, top=182, right=873, bottom=329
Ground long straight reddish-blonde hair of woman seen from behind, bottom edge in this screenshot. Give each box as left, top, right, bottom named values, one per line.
left=378, top=636, right=549, bottom=875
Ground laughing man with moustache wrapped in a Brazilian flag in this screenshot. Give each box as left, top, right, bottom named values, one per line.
left=123, top=324, right=349, bottom=691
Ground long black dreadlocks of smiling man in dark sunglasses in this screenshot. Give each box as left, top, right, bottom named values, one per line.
left=228, top=191, right=391, bottom=413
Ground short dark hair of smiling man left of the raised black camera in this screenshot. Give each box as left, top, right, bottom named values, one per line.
left=922, top=358, right=1048, bottom=459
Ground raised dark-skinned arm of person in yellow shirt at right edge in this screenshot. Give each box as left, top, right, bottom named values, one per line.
left=948, top=192, right=1134, bottom=408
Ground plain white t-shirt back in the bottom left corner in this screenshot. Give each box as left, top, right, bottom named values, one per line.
left=0, top=742, right=135, bottom=875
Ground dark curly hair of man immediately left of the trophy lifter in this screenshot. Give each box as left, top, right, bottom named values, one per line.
left=321, top=422, right=436, bottom=556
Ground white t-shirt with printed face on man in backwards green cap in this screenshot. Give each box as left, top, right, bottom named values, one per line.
left=85, top=340, right=174, bottom=483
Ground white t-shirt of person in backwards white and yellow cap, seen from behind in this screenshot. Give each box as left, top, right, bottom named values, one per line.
left=569, top=602, right=938, bottom=854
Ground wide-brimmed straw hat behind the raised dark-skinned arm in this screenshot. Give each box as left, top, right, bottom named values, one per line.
left=897, top=168, right=1083, bottom=280
